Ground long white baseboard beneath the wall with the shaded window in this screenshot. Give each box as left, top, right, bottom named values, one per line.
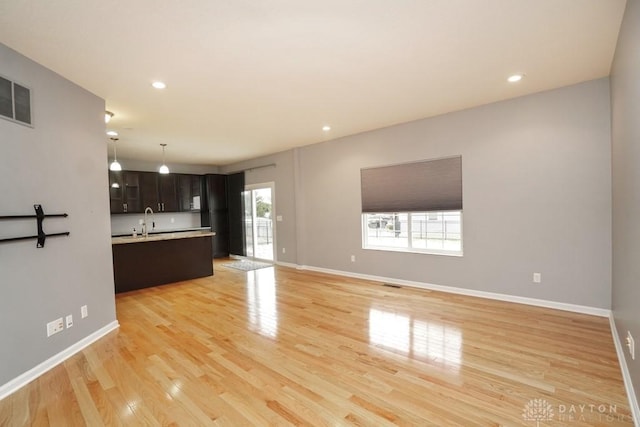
left=298, top=265, right=611, bottom=317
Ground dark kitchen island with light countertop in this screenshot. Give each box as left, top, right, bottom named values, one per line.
left=111, top=231, right=215, bottom=293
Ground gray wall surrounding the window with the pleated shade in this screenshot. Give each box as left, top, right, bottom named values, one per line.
left=223, top=79, right=611, bottom=309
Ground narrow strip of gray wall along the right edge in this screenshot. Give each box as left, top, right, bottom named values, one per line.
left=611, top=0, right=640, bottom=408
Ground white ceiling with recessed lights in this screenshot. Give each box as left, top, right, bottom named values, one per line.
left=0, top=0, right=626, bottom=165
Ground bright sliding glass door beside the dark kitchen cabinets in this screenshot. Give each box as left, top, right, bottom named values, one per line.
left=242, top=183, right=275, bottom=261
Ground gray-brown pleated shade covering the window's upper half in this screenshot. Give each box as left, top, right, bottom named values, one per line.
left=360, top=156, right=462, bottom=213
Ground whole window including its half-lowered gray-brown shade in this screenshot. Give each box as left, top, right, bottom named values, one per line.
left=360, top=156, right=462, bottom=255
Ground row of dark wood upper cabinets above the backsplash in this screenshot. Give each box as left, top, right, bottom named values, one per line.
left=109, top=171, right=203, bottom=214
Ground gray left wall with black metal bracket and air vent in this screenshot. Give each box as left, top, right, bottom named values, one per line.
left=0, top=44, right=116, bottom=386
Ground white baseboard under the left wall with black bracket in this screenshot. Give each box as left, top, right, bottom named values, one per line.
left=0, top=320, right=120, bottom=400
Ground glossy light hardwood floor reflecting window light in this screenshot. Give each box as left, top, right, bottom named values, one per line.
left=0, top=262, right=632, bottom=426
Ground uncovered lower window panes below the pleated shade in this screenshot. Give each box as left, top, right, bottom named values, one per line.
left=362, top=211, right=462, bottom=255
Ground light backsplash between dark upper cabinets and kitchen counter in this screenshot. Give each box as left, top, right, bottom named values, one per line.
left=111, top=212, right=201, bottom=235
